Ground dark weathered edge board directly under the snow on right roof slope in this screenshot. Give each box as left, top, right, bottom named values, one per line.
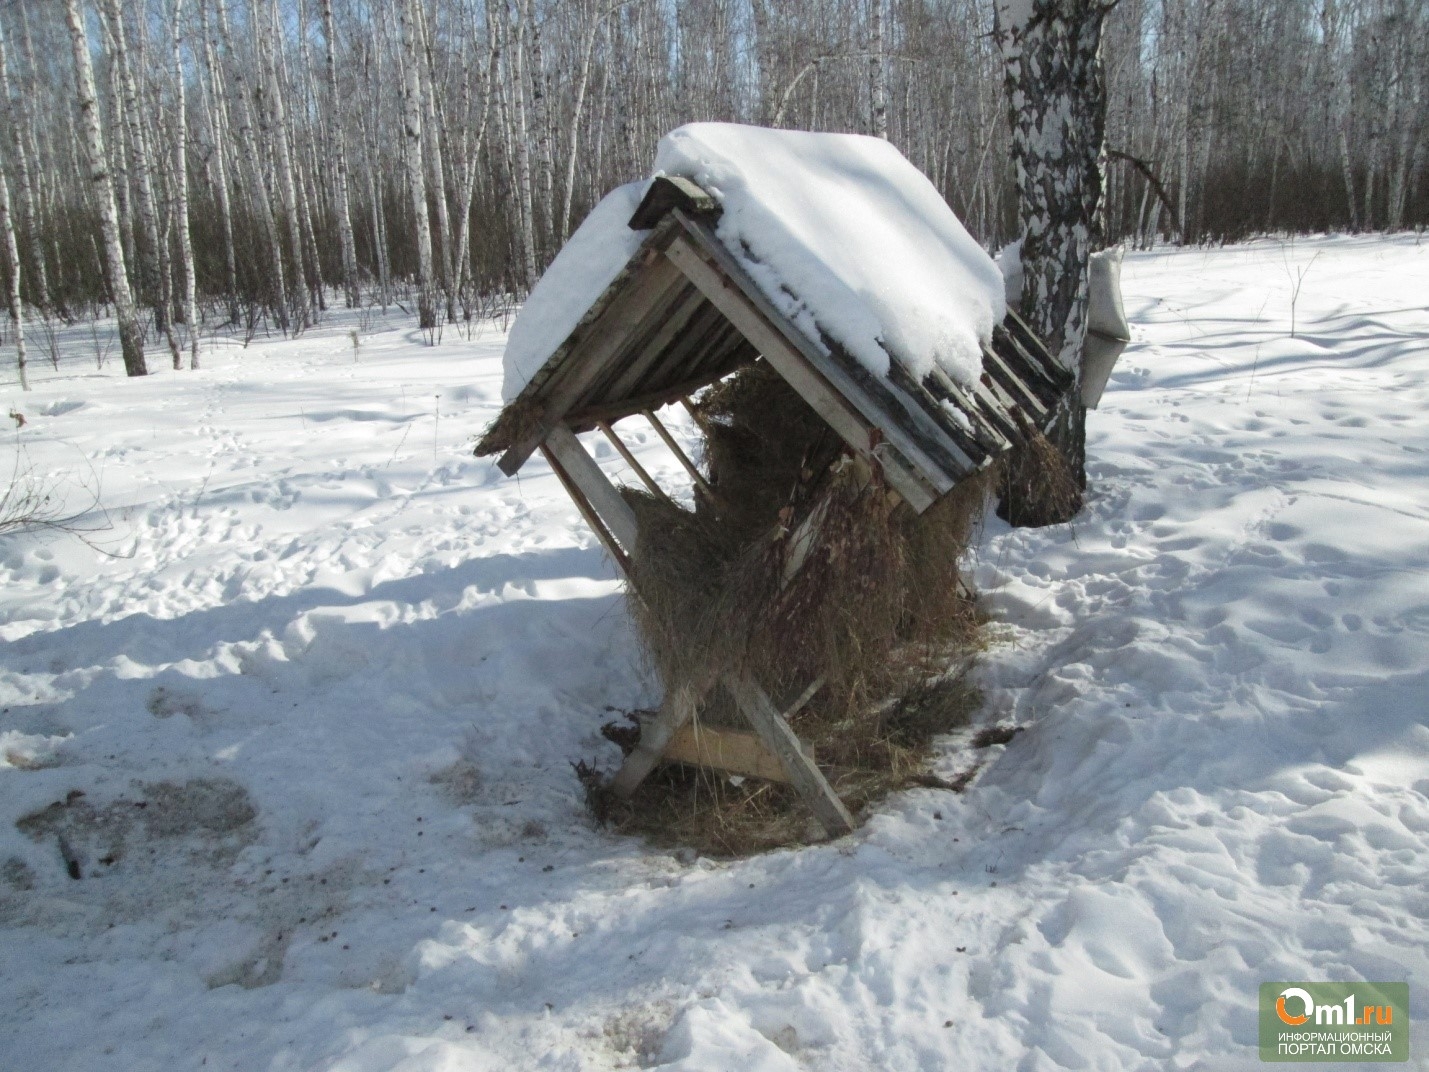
left=666, top=217, right=956, bottom=495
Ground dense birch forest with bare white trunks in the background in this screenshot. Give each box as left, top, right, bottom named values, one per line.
left=0, top=0, right=1429, bottom=383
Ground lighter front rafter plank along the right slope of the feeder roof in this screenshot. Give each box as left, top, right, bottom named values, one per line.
left=664, top=230, right=936, bottom=512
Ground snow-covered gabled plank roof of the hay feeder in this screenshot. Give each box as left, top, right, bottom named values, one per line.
left=477, top=123, right=1069, bottom=509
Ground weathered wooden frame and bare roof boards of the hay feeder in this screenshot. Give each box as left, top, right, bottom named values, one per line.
left=476, top=177, right=1072, bottom=836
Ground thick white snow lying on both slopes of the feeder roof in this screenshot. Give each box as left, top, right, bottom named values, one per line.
left=503, top=123, right=1006, bottom=402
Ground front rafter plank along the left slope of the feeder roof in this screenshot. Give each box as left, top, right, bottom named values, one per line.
left=496, top=256, right=683, bottom=476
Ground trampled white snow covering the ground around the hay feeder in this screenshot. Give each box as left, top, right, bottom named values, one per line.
left=0, top=236, right=1429, bottom=1072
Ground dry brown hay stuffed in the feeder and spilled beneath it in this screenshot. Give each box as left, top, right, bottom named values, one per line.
left=587, top=362, right=999, bottom=853
